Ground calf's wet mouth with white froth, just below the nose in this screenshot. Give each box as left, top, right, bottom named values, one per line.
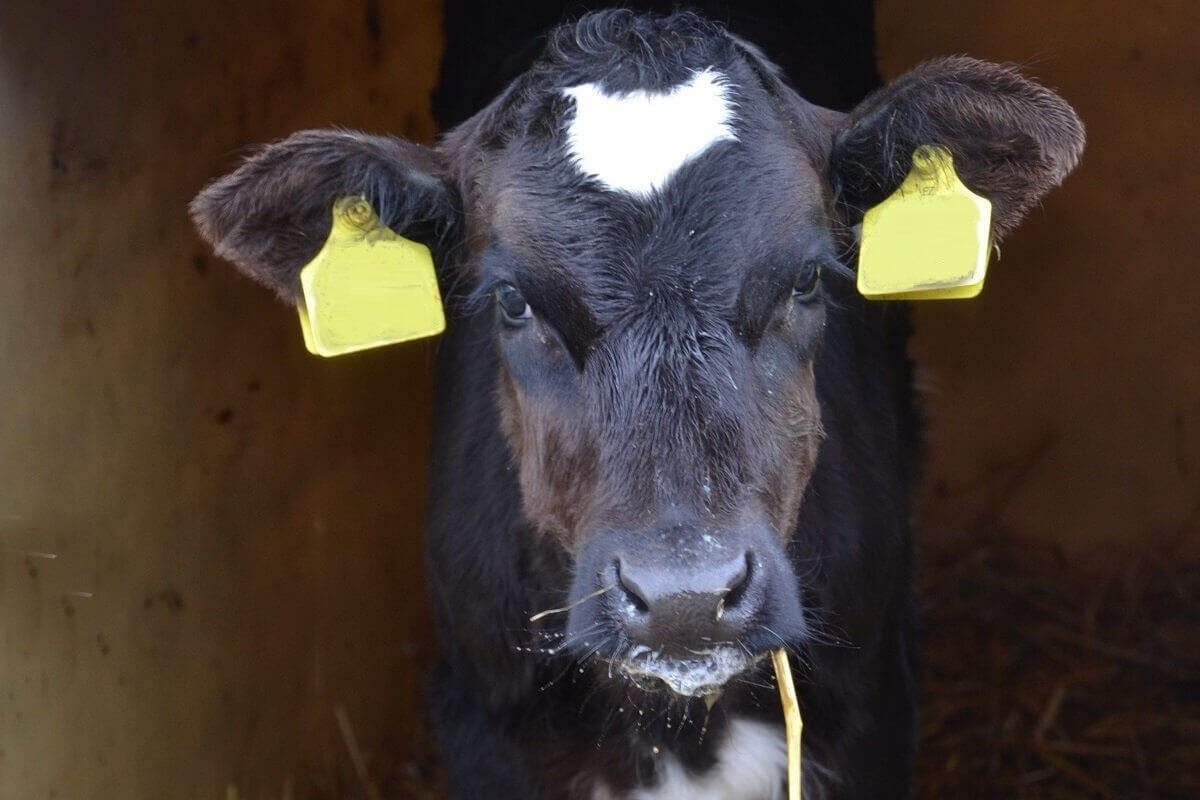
left=612, top=644, right=766, bottom=697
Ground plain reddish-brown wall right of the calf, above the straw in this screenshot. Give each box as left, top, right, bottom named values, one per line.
left=876, top=0, right=1200, bottom=561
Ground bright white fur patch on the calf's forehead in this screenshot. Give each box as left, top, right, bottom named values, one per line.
left=563, top=70, right=737, bottom=197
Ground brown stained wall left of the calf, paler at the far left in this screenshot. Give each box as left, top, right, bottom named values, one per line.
left=0, top=0, right=440, bottom=800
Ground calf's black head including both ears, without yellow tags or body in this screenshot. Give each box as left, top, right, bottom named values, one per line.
left=192, top=12, right=1084, bottom=694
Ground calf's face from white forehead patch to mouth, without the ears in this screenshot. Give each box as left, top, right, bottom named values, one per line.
left=448, top=47, right=846, bottom=693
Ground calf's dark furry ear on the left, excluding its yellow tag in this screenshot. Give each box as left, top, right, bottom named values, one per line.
left=190, top=130, right=460, bottom=301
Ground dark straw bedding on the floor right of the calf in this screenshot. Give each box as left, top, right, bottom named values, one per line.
left=917, top=539, right=1200, bottom=800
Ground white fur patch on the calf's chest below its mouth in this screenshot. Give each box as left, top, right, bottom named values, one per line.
left=594, top=720, right=787, bottom=800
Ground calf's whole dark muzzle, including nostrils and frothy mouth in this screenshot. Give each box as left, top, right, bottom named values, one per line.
left=566, top=527, right=806, bottom=697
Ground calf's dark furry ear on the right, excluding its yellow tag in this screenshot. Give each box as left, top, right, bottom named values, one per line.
left=830, top=56, right=1084, bottom=240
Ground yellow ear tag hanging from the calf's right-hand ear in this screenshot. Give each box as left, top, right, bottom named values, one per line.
left=858, top=145, right=991, bottom=300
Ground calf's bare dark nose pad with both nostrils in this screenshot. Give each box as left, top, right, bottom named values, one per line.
left=614, top=551, right=762, bottom=655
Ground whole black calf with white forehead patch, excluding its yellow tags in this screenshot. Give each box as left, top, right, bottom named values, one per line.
left=192, top=11, right=1084, bottom=800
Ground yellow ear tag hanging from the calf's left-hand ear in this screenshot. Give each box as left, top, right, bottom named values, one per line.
left=298, top=197, right=445, bottom=356
